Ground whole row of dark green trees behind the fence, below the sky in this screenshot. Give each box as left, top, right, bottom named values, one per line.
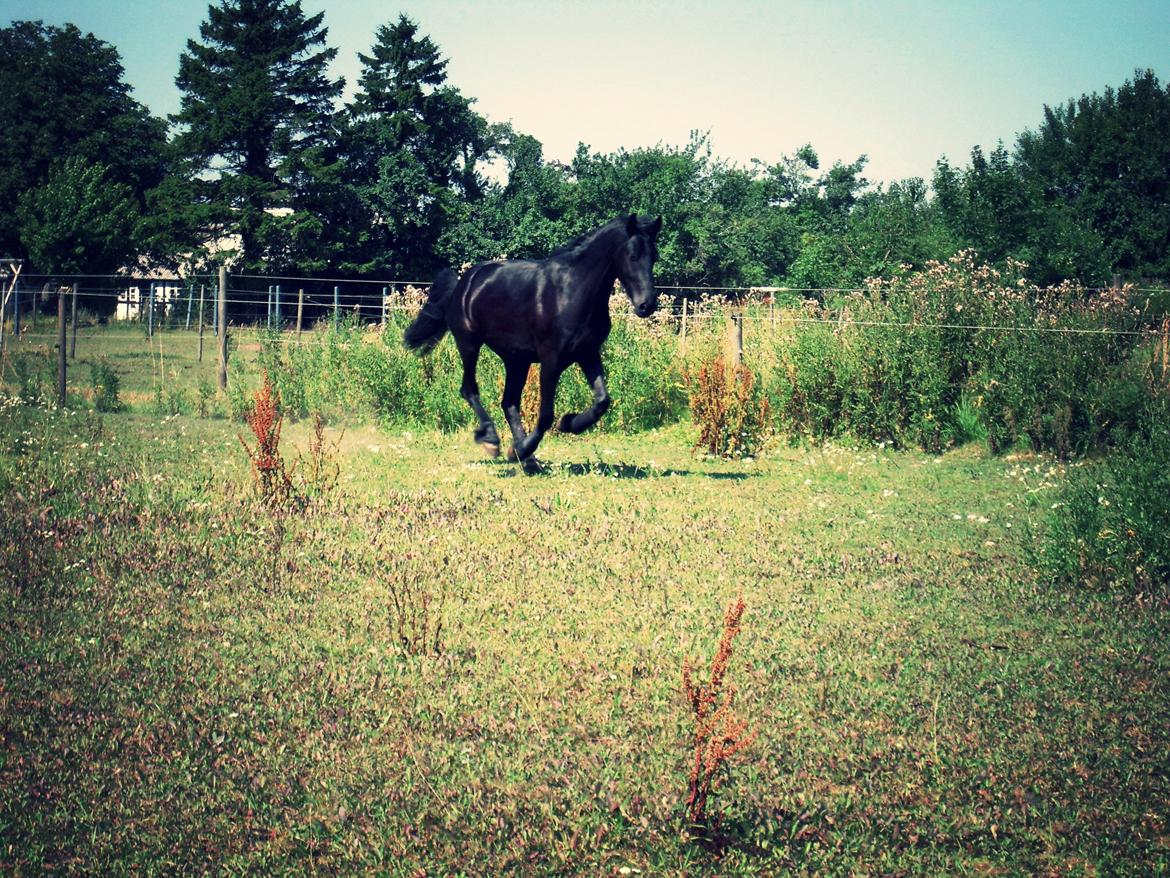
left=0, top=0, right=1170, bottom=306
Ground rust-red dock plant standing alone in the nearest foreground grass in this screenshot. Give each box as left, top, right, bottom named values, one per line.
left=682, top=596, right=756, bottom=829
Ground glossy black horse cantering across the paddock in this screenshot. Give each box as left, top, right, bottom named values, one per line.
left=405, top=214, right=662, bottom=461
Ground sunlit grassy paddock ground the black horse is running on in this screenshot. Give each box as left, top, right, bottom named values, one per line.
left=0, top=327, right=1170, bottom=876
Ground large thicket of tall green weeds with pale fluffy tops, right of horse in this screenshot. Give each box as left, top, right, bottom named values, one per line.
left=769, top=253, right=1145, bottom=457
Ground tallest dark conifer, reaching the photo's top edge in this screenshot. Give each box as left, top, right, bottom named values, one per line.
left=172, top=0, right=344, bottom=270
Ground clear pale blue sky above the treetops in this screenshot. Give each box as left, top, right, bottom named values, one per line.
left=9, top=0, right=1170, bottom=181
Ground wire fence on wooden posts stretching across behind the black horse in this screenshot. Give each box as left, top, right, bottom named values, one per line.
left=0, top=268, right=1170, bottom=416
